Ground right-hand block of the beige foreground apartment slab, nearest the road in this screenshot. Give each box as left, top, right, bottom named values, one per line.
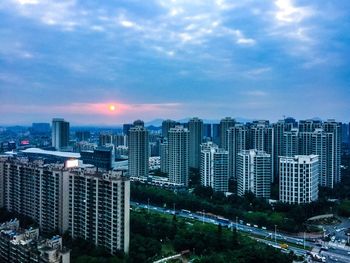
left=68, top=170, right=130, bottom=254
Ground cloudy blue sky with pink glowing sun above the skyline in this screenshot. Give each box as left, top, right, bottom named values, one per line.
left=0, top=0, right=350, bottom=125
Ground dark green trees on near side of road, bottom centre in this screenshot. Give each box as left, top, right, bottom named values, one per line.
left=129, top=212, right=294, bottom=263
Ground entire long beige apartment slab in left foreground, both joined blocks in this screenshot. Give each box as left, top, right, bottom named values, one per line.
left=0, top=157, right=130, bottom=254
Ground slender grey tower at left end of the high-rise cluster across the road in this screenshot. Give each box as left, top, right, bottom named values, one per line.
left=128, top=125, right=149, bottom=177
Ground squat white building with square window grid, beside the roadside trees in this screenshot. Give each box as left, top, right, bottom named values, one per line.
left=280, top=155, right=319, bottom=204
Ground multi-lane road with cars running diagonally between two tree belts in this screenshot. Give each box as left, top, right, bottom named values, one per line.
left=131, top=202, right=350, bottom=263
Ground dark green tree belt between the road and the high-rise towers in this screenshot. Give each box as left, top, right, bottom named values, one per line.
left=131, top=183, right=331, bottom=232
